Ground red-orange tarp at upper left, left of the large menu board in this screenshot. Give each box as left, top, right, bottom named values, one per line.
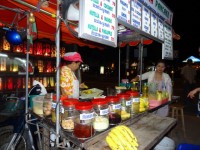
left=0, top=0, right=103, bottom=48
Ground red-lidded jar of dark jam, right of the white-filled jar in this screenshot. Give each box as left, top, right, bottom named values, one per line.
left=106, top=96, right=121, bottom=125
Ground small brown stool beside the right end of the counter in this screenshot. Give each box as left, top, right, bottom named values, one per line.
left=170, top=103, right=186, bottom=136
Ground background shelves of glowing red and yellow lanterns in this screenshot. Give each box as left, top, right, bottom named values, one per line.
left=0, top=37, right=66, bottom=91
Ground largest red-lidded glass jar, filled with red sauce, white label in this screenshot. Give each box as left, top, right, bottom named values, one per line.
left=73, top=102, right=94, bottom=140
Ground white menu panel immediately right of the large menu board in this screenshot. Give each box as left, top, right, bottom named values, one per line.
left=117, top=0, right=130, bottom=23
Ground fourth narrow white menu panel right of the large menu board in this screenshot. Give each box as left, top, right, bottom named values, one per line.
left=151, top=12, right=158, bottom=37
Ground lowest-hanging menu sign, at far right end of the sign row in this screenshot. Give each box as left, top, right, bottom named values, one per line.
left=162, top=24, right=173, bottom=59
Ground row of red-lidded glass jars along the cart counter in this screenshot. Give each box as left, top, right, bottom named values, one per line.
left=43, top=91, right=145, bottom=139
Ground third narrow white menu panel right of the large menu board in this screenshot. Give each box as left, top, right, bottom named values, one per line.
left=142, top=6, right=150, bottom=34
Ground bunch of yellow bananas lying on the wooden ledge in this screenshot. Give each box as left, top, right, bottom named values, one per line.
left=106, top=125, right=139, bottom=150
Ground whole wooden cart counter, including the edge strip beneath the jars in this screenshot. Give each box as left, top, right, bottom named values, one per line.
left=29, top=101, right=176, bottom=150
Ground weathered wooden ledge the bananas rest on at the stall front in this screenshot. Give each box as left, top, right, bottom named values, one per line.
left=84, top=113, right=176, bottom=150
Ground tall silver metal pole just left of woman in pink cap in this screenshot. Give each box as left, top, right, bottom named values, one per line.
left=56, top=0, right=60, bottom=146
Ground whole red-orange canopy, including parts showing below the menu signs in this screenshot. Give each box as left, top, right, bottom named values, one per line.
left=0, top=0, right=180, bottom=49
